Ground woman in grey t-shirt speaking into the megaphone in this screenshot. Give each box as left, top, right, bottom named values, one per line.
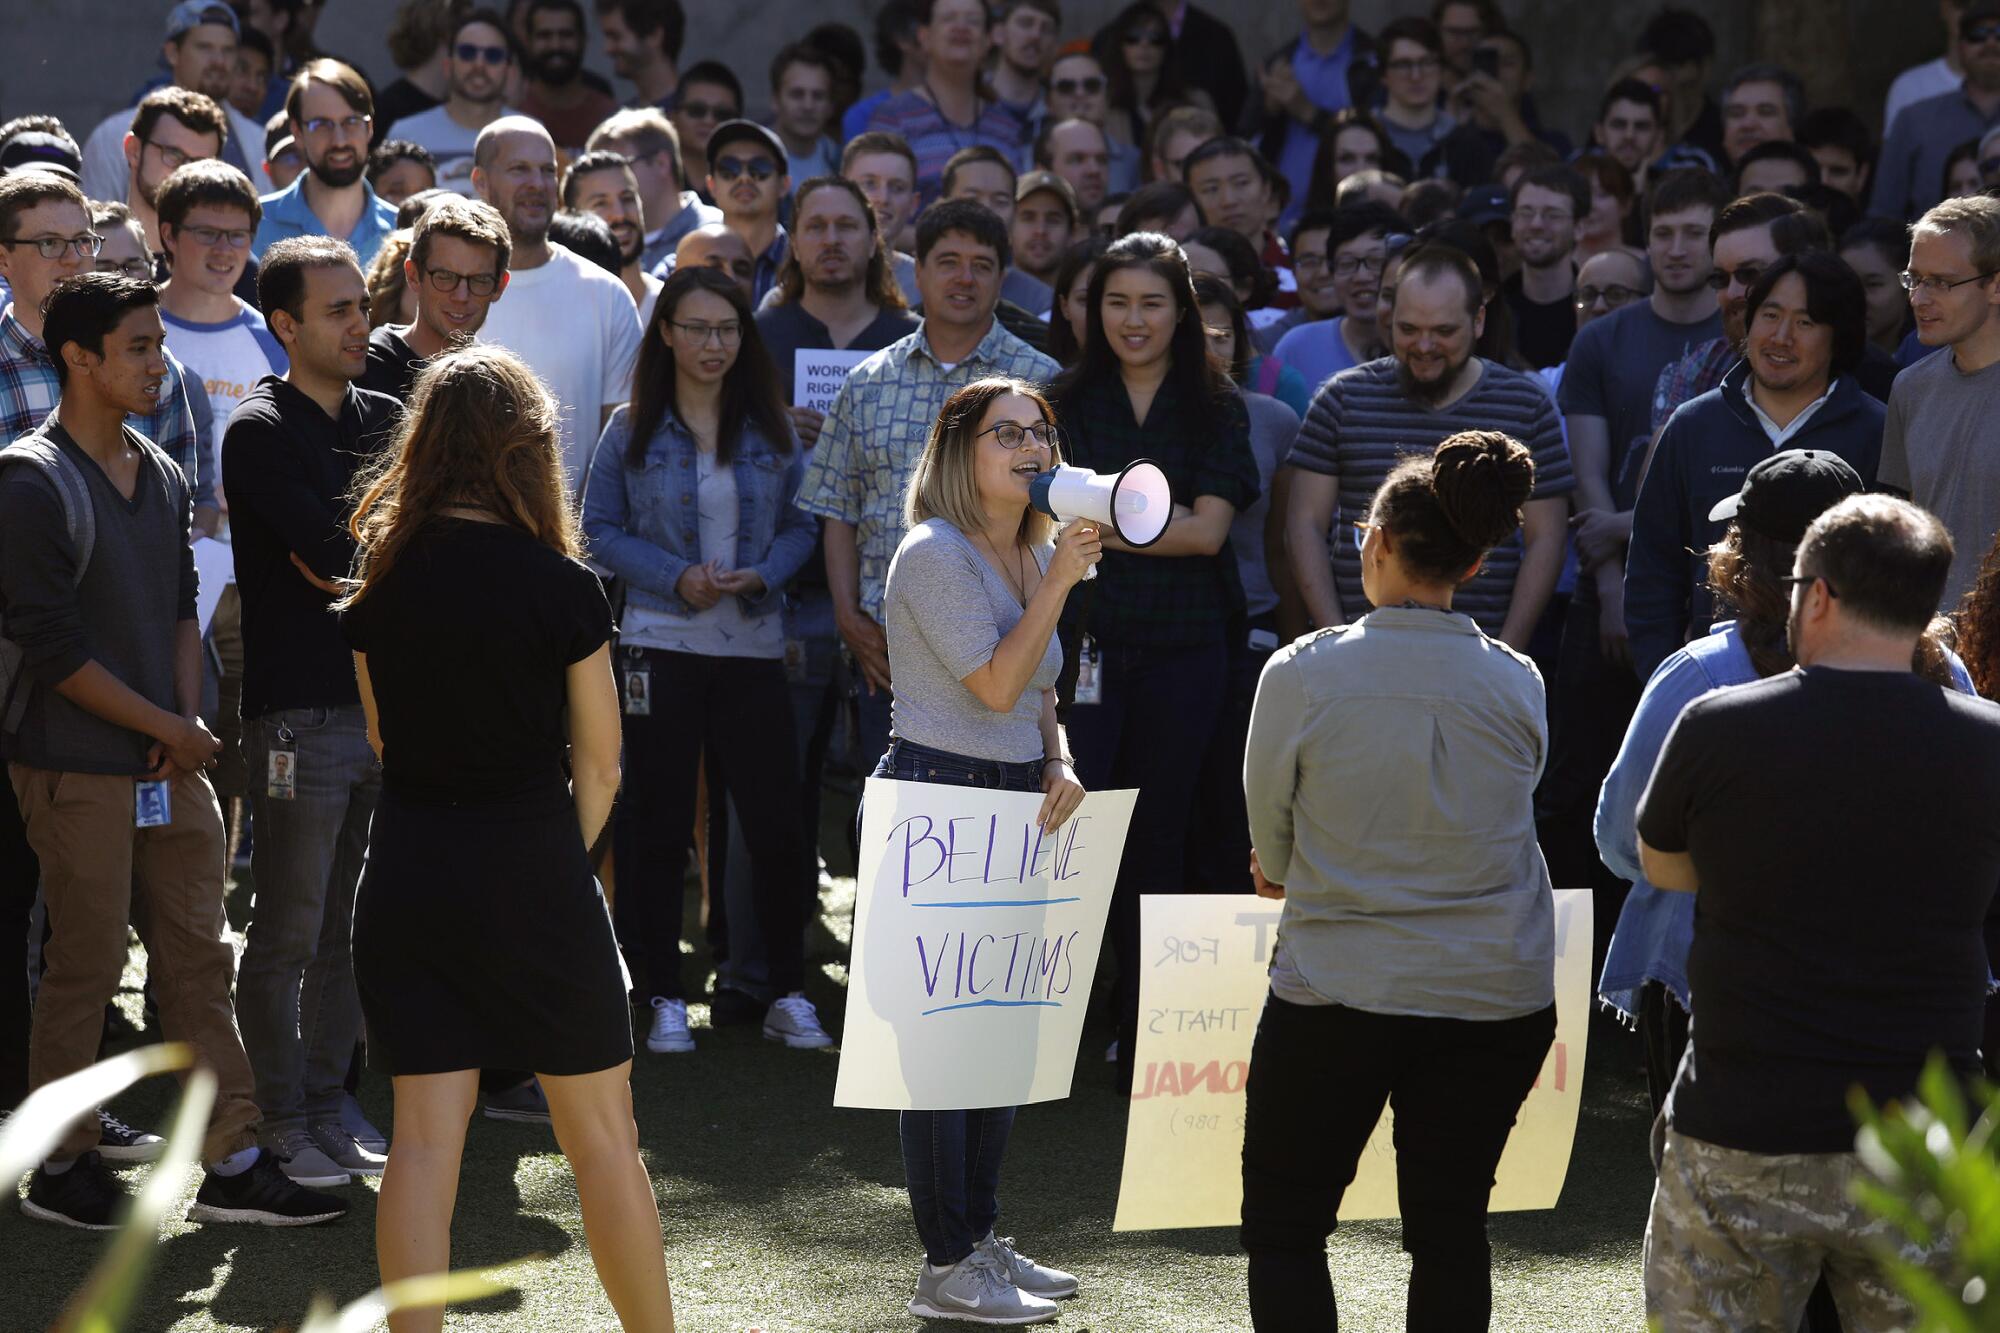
left=874, top=378, right=1102, bottom=1325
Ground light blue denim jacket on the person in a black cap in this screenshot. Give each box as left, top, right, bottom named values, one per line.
left=1596, top=620, right=1974, bottom=1019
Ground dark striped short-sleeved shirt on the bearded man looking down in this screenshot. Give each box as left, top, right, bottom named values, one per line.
left=1290, top=356, right=1576, bottom=634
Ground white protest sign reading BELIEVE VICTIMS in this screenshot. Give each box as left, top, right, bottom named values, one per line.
left=834, top=779, right=1138, bottom=1111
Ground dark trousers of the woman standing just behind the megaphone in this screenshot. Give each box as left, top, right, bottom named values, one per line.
left=1068, top=628, right=1224, bottom=1087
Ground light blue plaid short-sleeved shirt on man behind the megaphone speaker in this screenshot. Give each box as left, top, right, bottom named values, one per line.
left=798, top=320, right=1060, bottom=620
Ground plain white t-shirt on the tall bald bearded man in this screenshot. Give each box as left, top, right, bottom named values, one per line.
left=480, top=242, right=640, bottom=494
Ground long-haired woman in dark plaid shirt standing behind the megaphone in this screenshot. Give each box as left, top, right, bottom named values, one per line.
left=1050, top=232, right=1260, bottom=1089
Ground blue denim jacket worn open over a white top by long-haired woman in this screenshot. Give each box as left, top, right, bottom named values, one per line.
left=584, top=406, right=814, bottom=616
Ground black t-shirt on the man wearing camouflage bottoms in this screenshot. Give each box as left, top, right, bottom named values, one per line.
left=1638, top=667, right=2000, bottom=1153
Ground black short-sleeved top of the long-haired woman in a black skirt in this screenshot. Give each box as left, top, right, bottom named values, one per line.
left=340, top=518, right=612, bottom=805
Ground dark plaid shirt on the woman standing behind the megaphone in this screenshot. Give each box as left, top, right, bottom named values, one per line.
left=1056, top=376, right=1262, bottom=648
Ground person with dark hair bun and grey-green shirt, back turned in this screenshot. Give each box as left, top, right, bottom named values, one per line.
left=1242, top=430, right=1556, bottom=1331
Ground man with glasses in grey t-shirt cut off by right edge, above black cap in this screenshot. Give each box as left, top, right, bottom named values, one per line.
left=1880, top=193, right=2000, bottom=610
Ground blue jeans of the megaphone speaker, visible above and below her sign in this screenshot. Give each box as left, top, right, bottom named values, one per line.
left=874, top=741, right=1042, bottom=1269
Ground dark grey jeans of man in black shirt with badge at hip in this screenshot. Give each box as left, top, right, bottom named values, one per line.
left=236, top=705, right=382, bottom=1133
